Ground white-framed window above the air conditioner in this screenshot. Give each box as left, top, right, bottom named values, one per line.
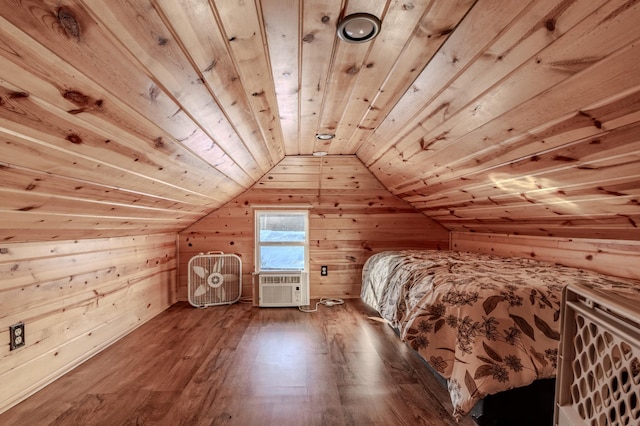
left=256, top=210, right=309, bottom=272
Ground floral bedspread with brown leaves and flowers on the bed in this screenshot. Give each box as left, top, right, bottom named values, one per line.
left=361, top=250, right=640, bottom=419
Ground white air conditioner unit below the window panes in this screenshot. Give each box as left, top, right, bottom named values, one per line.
left=258, top=272, right=309, bottom=307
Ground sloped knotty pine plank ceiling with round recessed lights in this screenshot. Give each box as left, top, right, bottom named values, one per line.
left=0, top=0, right=640, bottom=241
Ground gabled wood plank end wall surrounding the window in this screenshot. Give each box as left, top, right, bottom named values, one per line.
left=178, top=155, right=449, bottom=300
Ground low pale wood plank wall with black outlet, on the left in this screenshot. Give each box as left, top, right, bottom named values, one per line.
left=0, top=234, right=177, bottom=412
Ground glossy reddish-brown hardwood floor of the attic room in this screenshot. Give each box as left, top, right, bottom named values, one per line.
left=0, top=300, right=474, bottom=426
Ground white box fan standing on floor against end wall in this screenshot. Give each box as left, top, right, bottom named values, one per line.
left=188, top=252, right=242, bottom=308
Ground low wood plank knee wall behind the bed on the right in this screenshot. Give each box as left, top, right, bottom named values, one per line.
left=451, top=232, right=640, bottom=279
